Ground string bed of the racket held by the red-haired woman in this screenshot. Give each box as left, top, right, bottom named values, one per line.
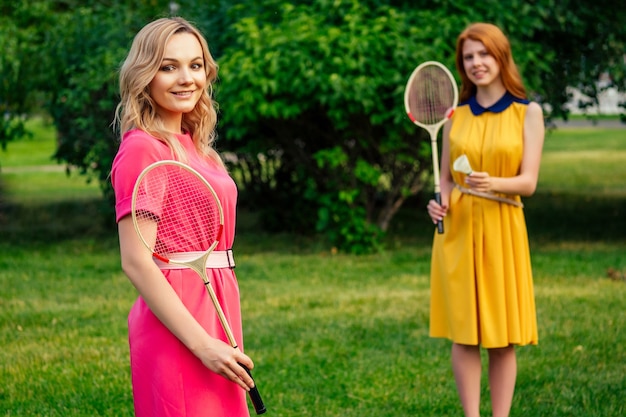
left=408, top=65, right=455, bottom=125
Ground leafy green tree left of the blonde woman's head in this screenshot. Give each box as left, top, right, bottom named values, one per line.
left=2, top=0, right=199, bottom=196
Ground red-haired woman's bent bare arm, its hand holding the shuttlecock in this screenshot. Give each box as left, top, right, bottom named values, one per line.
left=466, top=102, right=545, bottom=196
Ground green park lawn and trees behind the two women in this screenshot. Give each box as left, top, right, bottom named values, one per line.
left=0, top=0, right=626, bottom=416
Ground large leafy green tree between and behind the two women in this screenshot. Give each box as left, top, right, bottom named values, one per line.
left=218, top=0, right=624, bottom=251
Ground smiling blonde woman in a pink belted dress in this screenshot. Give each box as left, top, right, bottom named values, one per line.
left=111, top=18, right=254, bottom=417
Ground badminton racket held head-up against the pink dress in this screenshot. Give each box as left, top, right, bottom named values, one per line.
left=131, top=160, right=266, bottom=414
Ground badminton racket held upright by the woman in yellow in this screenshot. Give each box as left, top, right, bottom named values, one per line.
left=404, top=61, right=459, bottom=233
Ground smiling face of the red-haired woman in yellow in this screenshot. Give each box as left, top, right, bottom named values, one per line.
left=463, top=39, right=502, bottom=88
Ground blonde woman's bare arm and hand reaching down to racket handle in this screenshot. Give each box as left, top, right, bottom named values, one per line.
left=118, top=216, right=254, bottom=390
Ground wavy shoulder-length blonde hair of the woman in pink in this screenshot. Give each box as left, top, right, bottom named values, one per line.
left=113, top=17, right=224, bottom=166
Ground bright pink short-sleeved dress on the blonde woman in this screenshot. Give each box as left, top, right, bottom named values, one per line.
left=111, top=130, right=250, bottom=417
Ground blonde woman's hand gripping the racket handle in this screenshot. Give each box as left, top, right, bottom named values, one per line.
left=193, top=339, right=254, bottom=391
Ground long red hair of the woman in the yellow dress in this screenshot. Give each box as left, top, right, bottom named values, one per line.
left=456, top=23, right=527, bottom=102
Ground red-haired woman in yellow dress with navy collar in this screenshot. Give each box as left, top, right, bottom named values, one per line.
left=428, top=23, right=544, bottom=417
